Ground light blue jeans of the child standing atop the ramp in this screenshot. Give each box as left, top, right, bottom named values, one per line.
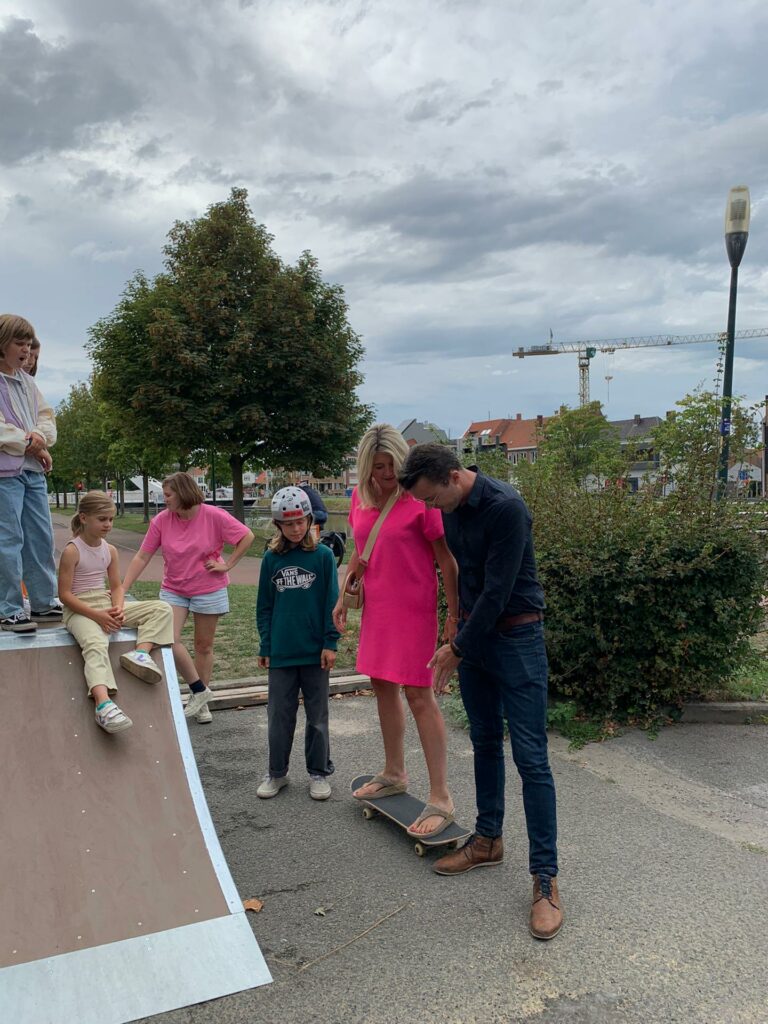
left=0, top=469, right=56, bottom=618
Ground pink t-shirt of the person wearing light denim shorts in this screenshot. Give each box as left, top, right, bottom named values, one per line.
left=141, top=505, right=248, bottom=597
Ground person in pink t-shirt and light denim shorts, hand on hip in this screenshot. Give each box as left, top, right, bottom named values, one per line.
left=123, top=473, right=253, bottom=722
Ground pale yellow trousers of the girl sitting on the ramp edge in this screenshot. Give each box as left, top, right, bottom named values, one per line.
left=63, top=590, right=173, bottom=693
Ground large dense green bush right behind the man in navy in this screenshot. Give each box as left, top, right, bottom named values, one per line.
left=523, top=483, right=766, bottom=722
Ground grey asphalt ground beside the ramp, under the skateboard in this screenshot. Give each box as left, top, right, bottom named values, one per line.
left=135, top=696, right=768, bottom=1024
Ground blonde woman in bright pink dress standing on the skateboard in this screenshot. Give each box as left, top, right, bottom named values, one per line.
left=334, top=424, right=459, bottom=836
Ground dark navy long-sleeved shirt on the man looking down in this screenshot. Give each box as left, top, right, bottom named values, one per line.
left=442, top=466, right=545, bottom=657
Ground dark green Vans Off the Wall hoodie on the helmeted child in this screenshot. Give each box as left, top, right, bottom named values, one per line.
left=256, top=544, right=339, bottom=669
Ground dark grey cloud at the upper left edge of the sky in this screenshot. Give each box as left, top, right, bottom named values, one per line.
left=0, top=18, right=139, bottom=164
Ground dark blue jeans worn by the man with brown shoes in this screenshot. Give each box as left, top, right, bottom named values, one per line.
left=459, top=623, right=557, bottom=876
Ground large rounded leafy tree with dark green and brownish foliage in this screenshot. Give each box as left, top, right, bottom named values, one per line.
left=91, top=188, right=371, bottom=517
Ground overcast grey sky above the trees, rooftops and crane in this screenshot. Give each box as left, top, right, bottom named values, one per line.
left=0, top=0, right=768, bottom=434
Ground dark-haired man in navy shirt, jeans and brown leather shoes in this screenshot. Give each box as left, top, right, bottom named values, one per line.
left=399, top=444, right=562, bottom=939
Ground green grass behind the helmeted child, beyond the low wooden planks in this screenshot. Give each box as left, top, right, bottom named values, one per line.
left=131, top=580, right=360, bottom=681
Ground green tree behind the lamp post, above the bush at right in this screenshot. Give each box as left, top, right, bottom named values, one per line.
left=653, top=388, right=760, bottom=501
